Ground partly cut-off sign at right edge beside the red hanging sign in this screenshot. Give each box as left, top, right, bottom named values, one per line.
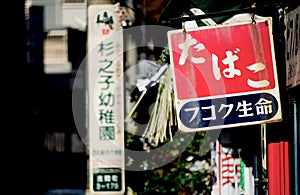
left=285, top=6, right=300, bottom=88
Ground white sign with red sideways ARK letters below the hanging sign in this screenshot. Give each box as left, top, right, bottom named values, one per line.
left=211, top=141, right=254, bottom=195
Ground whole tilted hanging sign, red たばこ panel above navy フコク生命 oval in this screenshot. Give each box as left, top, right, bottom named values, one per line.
left=168, top=17, right=282, bottom=132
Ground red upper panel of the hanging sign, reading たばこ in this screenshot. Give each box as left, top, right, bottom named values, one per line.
left=169, top=20, right=276, bottom=99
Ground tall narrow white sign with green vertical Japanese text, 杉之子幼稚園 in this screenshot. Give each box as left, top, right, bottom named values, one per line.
left=87, top=4, right=125, bottom=194
